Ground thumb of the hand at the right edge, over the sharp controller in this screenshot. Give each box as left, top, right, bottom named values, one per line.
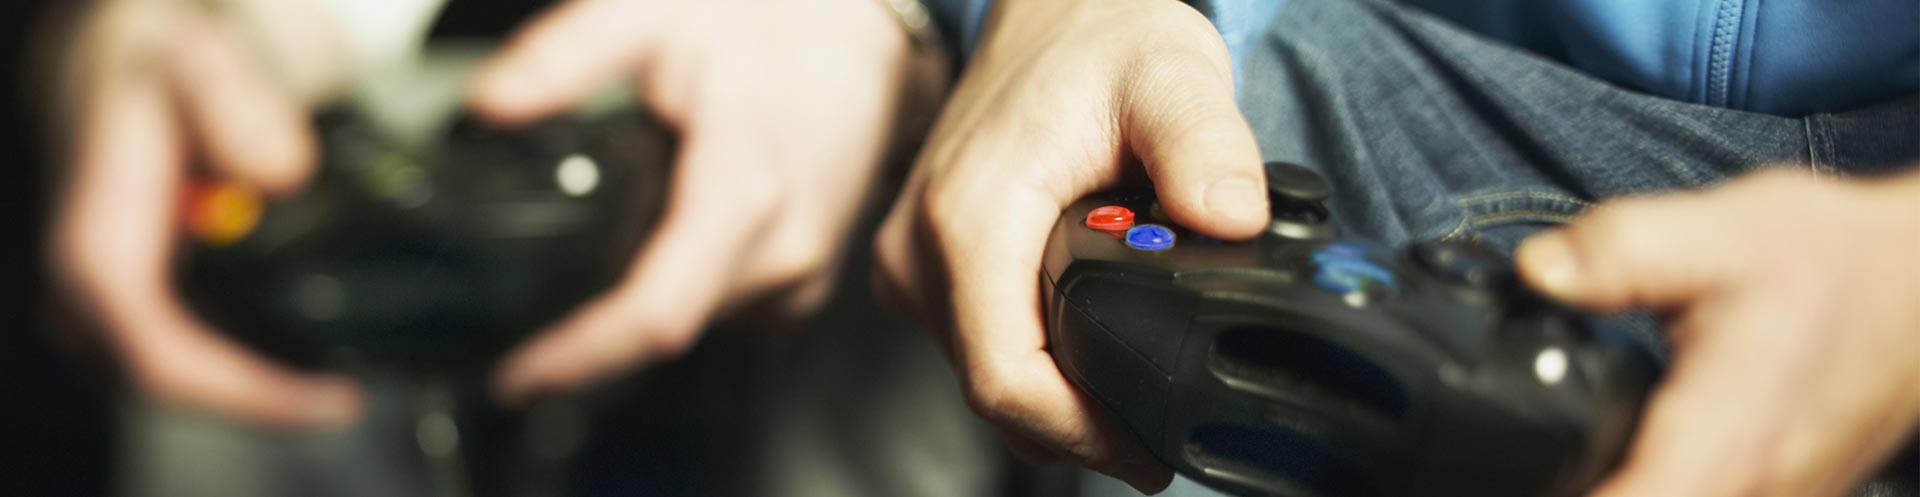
left=1515, top=194, right=1741, bottom=311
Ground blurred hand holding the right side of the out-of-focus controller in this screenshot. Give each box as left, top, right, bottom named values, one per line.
left=470, top=0, right=945, bottom=403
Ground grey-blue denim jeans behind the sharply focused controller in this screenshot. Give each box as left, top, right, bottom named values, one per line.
left=1083, top=0, right=1920, bottom=495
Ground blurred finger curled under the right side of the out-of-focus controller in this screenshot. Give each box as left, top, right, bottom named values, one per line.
left=495, top=127, right=783, bottom=405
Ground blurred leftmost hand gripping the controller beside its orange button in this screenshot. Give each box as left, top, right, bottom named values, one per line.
left=50, top=2, right=361, bottom=428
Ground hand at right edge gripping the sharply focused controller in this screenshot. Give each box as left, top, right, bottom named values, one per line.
left=1517, top=171, right=1920, bottom=497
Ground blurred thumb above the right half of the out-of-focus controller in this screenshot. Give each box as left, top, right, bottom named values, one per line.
left=468, top=0, right=678, bottom=123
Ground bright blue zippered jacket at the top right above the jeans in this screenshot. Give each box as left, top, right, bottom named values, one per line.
left=929, top=0, right=1920, bottom=115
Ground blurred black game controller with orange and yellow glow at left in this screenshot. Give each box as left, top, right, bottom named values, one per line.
left=177, top=109, right=674, bottom=367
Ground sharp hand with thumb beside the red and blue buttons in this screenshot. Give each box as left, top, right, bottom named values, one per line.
left=876, top=0, right=1267, bottom=491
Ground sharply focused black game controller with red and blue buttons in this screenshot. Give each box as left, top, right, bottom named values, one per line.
left=1044, top=163, right=1657, bottom=497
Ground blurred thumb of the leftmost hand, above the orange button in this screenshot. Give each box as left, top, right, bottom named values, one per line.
left=169, top=23, right=315, bottom=192
